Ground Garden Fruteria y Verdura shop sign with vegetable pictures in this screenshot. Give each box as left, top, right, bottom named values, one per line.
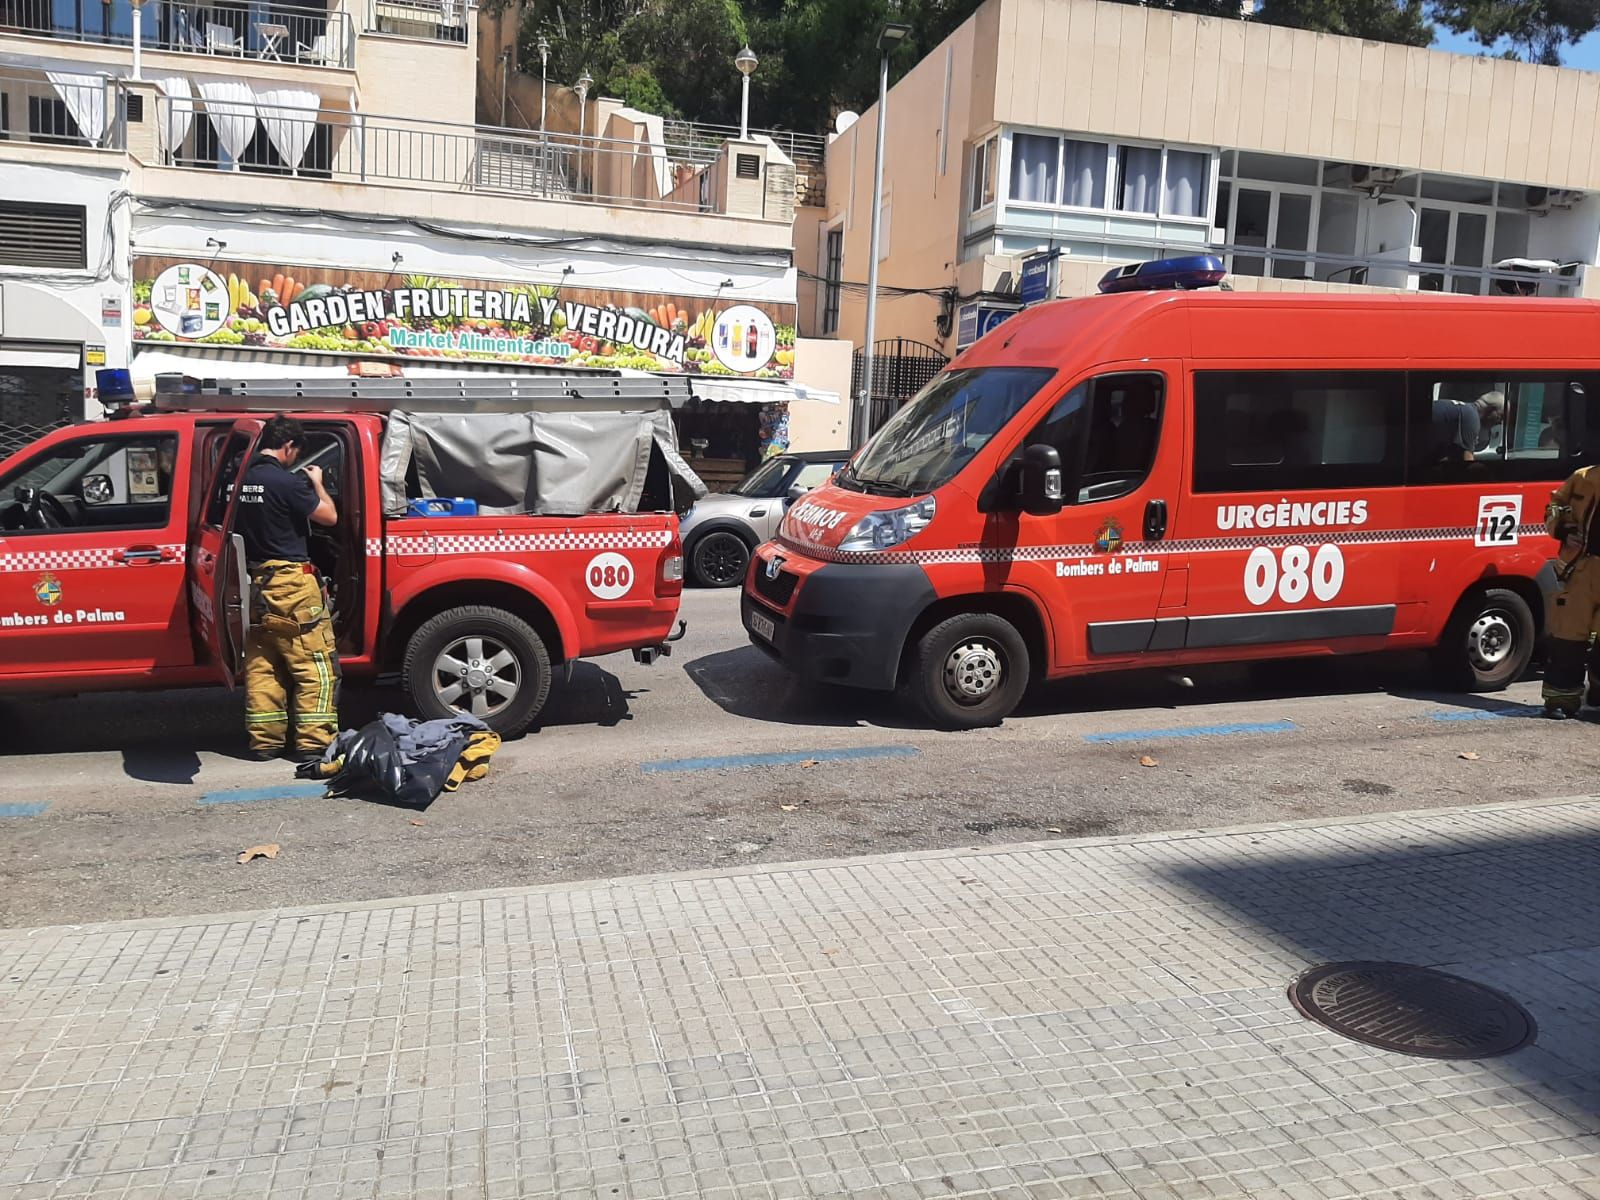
left=133, top=256, right=795, bottom=379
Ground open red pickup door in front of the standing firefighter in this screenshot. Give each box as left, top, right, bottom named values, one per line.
left=189, top=421, right=262, bottom=688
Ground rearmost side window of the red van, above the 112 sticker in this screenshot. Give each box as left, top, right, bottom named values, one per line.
left=1410, top=371, right=1592, bottom=483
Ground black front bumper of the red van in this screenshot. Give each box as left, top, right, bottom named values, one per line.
left=739, top=557, right=936, bottom=691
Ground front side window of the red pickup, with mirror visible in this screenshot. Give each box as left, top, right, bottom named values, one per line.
left=0, top=434, right=178, bottom=534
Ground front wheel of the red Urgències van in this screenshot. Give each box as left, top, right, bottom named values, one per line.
left=902, top=613, right=1029, bottom=730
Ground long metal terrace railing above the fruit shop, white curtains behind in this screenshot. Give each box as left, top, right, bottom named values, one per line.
left=157, top=96, right=732, bottom=211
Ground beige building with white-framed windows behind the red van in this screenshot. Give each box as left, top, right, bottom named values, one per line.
left=819, top=0, right=1600, bottom=419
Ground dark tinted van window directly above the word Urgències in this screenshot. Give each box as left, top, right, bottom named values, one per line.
left=1195, top=371, right=1405, bottom=491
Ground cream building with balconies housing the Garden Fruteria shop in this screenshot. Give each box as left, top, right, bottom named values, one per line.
left=0, top=0, right=848, bottom=474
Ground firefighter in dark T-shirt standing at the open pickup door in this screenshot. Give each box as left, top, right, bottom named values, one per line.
left=235, top=416, right=341, bottom=762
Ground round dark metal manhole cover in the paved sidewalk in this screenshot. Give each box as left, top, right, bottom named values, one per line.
left=1290, top=963, right=1538, bottom=1058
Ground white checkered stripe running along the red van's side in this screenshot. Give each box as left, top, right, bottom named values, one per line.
left=778, top=525, right=1549, bottom=565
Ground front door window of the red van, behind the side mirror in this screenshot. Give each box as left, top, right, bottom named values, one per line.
left=1022, top=373, right=1166, bottom=504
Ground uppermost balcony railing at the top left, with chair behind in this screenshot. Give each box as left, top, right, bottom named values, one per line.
left=0, top=0, right=354, bottom=67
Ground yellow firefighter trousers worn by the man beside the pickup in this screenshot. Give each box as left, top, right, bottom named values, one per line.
left=245, top=562, right=341, bottom=754
